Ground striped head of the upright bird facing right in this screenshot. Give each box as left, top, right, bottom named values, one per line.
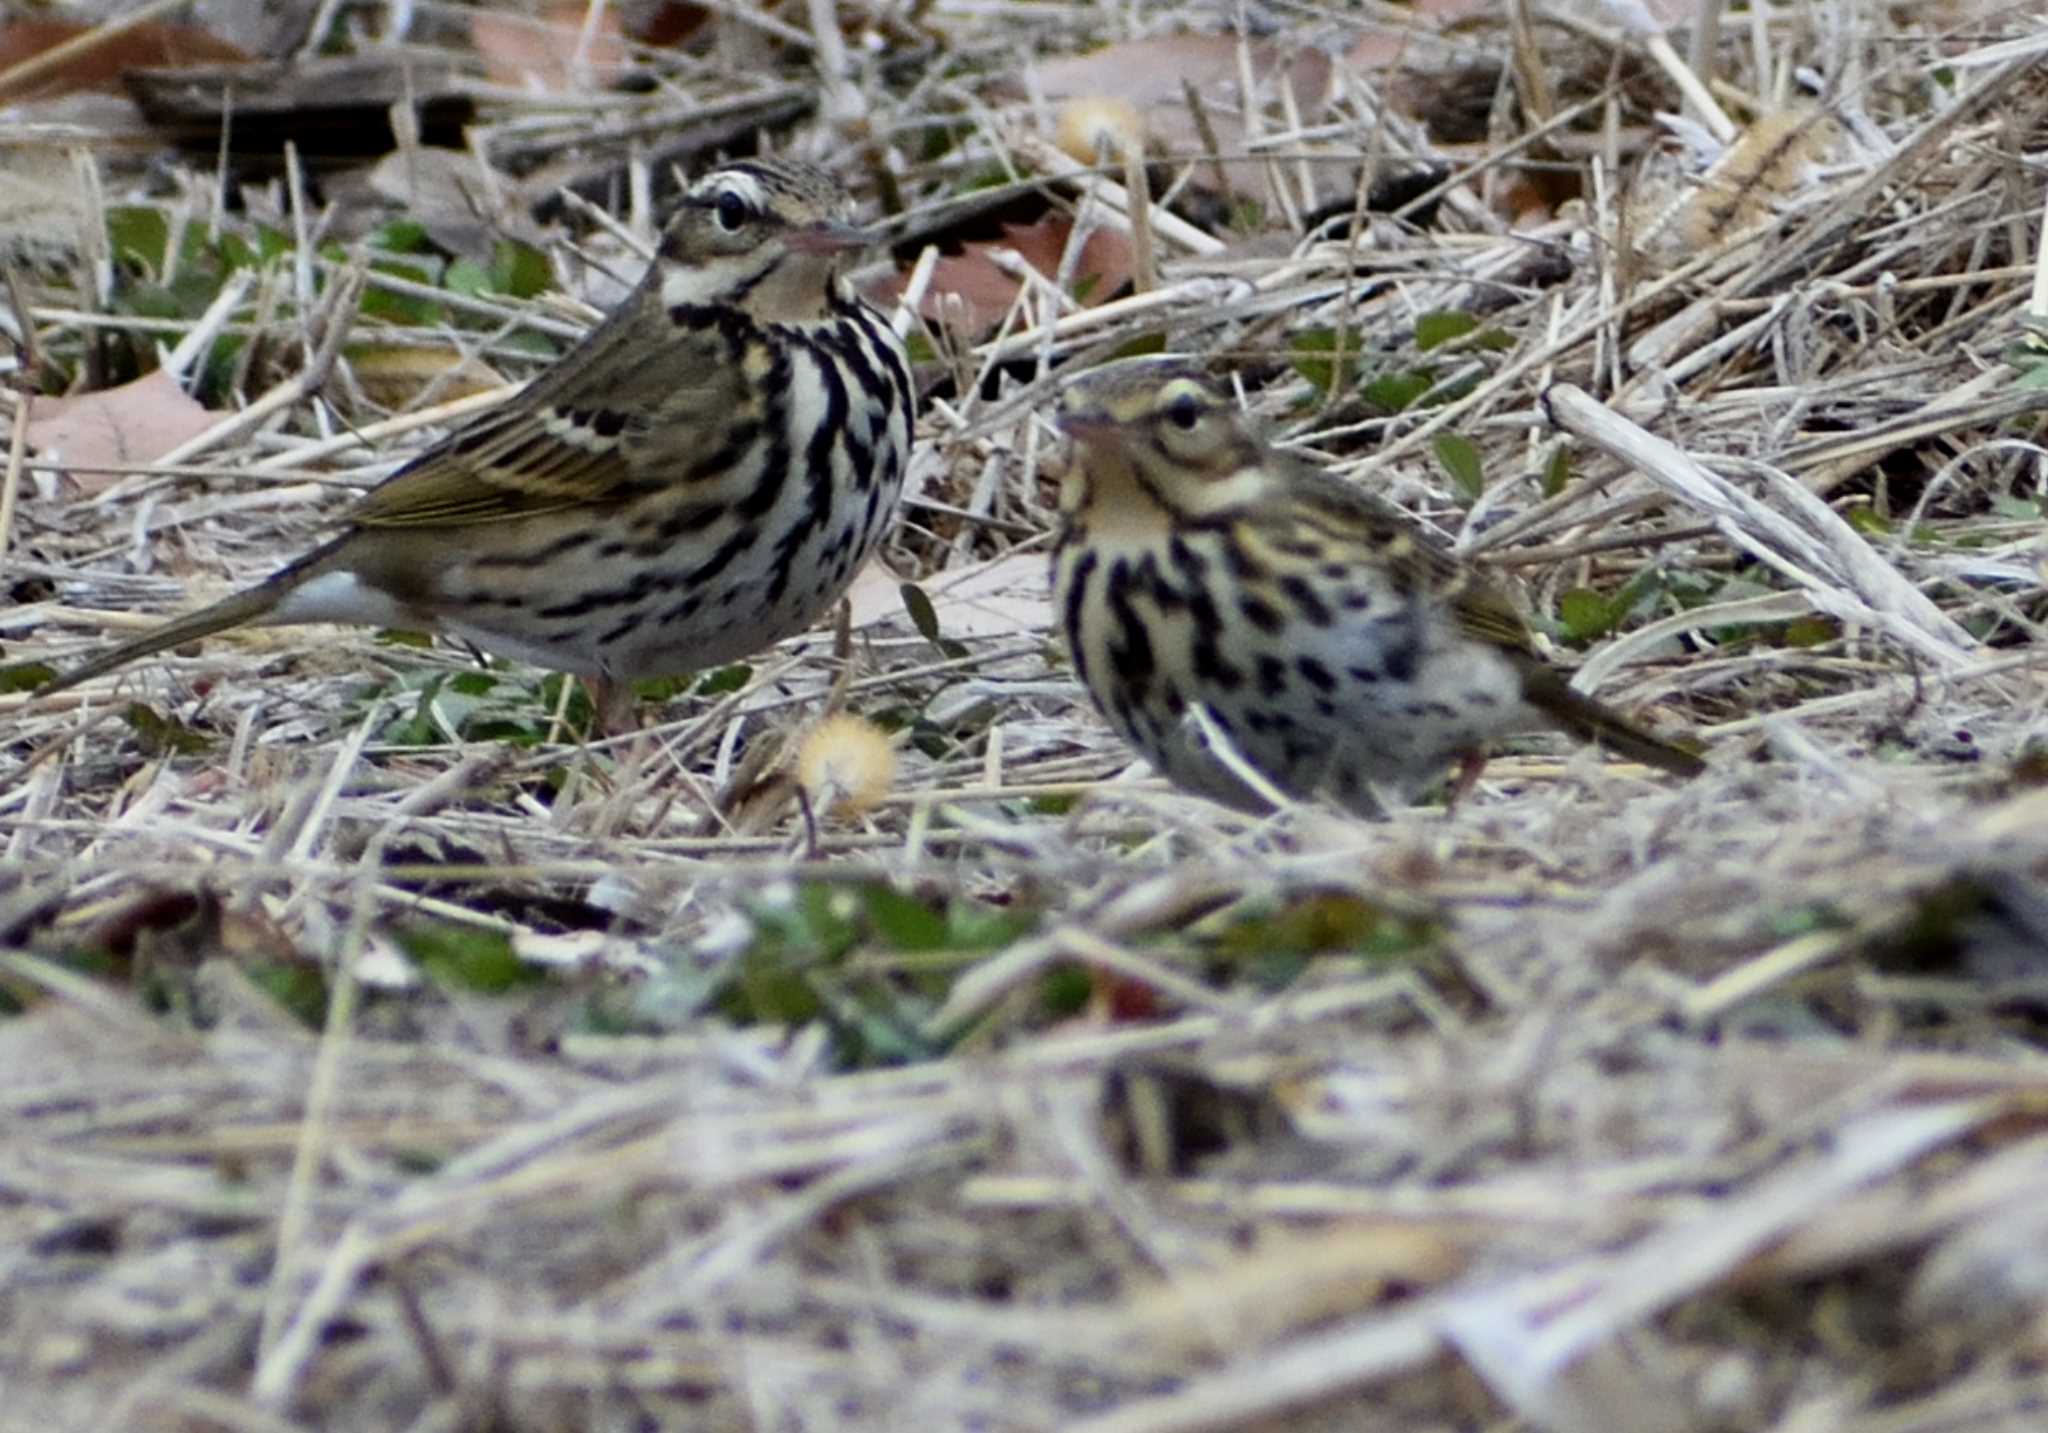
left=655, top=160, right=874, bottom=323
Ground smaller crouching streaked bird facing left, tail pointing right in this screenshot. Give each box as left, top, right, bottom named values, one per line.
left=1053, top=360, right=1702, bottom=817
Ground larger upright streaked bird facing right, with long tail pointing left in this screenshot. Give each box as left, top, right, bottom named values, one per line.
left=29, top=160, right=915, bottom=729
